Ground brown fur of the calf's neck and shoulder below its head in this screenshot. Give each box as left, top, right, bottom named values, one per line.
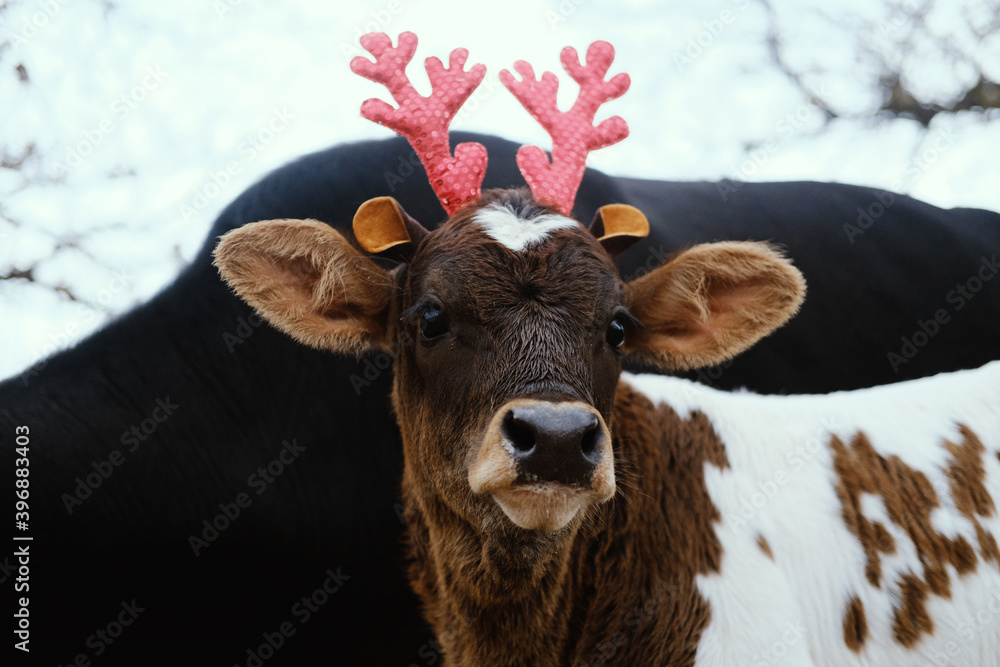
left=406, top=383, right=740, bottom=667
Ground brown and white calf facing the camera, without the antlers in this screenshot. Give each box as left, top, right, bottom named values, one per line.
left=216, top=190, right=1000, bottom=667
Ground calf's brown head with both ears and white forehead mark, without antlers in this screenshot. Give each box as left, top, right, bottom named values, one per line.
left=216, top=190, right=804, bottom=534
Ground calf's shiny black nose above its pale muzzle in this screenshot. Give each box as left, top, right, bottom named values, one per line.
left=500, top=403, right=604, bottom=486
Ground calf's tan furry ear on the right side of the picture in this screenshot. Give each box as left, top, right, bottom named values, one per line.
left=625, top=242, right=806, bottom=370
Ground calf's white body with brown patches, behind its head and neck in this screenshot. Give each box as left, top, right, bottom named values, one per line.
left=616, top=362, right=1000, bottom=666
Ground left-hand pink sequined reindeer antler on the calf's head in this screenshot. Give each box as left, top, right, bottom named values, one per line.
left=351, top=32, right=486, bottom=215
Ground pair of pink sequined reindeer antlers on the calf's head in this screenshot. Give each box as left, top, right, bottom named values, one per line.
left=351, top=32, right=630, bottom=215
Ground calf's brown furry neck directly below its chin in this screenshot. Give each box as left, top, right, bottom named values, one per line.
left=404, top=472, right=593, bottom=665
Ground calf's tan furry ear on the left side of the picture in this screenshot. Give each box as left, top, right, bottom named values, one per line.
left=214, top=220, right=397, bottom=355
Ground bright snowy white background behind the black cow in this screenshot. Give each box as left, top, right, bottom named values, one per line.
left=0, top=0, right=1000, bottom=378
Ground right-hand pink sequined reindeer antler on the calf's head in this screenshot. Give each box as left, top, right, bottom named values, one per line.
left=500, top=42, right=630, bottom=215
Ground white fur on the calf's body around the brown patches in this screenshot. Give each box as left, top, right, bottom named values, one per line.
left=622, top=362, right=1000, bottom=667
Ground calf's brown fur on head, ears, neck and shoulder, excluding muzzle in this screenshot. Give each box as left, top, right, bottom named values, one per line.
left=209, top=190, right=804, bottom=667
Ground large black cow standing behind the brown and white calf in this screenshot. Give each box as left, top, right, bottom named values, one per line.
left=0, top=133, right=1000, bottom=666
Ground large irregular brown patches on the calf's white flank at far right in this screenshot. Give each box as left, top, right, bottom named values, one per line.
left=830, top=426, right=997, bottom=647
